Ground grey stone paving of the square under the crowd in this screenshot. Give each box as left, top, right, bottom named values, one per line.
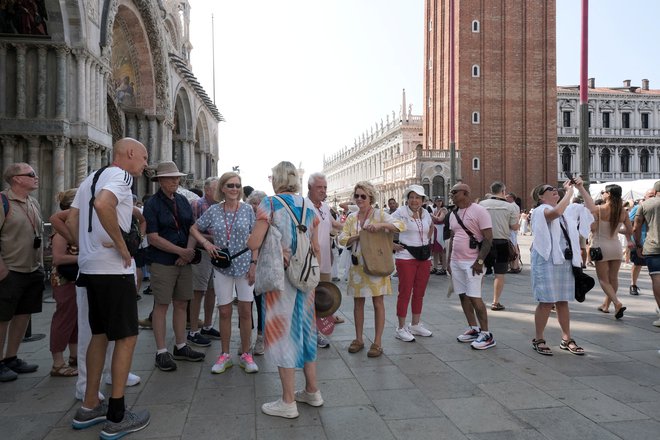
left=0, top=237, right=660, bottom=440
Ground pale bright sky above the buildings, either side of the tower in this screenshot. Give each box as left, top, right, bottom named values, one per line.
left=190, top=0, right=660, bottom=192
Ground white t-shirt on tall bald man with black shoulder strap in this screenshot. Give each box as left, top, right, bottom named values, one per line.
left=71, top=167, right=133, bottom=275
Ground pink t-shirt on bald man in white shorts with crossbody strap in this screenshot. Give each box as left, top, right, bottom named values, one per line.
left=449, top=203, right=493, bottom=261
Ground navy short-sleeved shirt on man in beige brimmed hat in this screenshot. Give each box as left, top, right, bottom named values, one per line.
left=142, top=190, right=194, bottom=266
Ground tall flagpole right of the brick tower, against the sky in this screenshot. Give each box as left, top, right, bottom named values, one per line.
left=580, top=0, right=590, bottom=189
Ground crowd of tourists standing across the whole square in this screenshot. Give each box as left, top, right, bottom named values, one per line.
left=0, top=138, right=660, bottom=439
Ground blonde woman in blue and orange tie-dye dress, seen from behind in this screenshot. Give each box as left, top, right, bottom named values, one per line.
left=248, top=162, right=323, bottom=418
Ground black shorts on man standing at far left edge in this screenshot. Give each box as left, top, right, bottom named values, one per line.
left=0, top=269, right=44, bottom=322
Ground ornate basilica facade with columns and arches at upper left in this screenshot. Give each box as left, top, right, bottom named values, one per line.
left=0, top=0, right=223, bottom=215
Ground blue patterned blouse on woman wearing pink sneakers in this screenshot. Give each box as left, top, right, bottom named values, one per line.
left=196, top=202, right=255, bottom=277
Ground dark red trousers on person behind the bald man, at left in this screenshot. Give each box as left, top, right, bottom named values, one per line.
left=50, top=283, right=78, bottom=356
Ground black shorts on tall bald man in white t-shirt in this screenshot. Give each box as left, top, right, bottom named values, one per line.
left=82, top=274, right=138, bottom=341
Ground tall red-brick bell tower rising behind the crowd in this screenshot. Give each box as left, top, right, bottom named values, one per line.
left=424, top=0, right=558, bottom=209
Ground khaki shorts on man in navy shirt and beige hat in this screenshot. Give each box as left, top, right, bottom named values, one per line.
left=151, top=263, right=193, bottom=304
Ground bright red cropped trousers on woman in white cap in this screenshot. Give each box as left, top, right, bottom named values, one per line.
left=396, top=259, right=431, bottom=318
